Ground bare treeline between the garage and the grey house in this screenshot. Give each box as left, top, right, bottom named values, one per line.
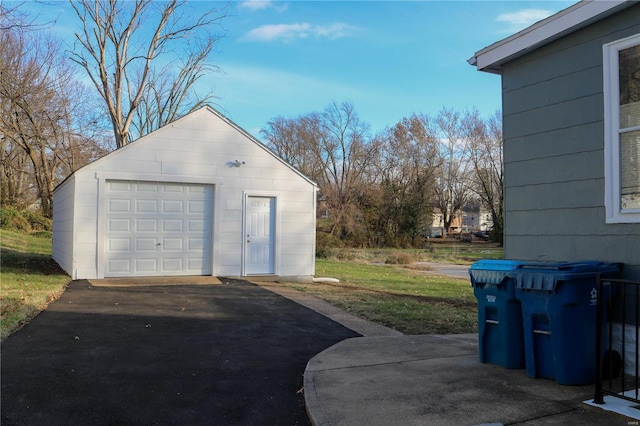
left=262, top=102, right=503, bottom=247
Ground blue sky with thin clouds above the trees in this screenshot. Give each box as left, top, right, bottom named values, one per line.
left=23, top=0, right=575, bottom=136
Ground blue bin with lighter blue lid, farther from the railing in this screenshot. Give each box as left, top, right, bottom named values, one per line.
left=469, top=260, right=525, bottom=369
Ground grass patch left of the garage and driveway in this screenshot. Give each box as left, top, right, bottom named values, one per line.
left=0, top=230, right=71, bottom=340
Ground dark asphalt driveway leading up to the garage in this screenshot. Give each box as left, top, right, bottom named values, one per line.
left=0, top=279, right=358, bottom=425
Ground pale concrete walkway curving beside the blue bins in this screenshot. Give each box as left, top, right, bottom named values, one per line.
left=259, top=283, right=638, bottom=426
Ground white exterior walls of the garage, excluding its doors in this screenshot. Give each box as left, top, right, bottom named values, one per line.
left=54, top=107, right=316, bottom=279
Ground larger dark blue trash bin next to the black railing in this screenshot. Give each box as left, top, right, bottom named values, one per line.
left=510, top=261, right=621, bottom=385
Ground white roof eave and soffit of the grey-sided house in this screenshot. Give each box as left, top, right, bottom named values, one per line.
left=467, top=0, right=634, bottom=74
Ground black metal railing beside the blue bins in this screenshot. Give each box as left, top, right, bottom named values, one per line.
left=594, top=276, right=640, bottom=404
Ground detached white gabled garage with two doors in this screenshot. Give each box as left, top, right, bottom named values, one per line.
left=53, top=107, right=317, bottom=280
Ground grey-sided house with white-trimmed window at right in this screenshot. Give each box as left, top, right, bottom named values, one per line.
left=469, top=1, right=640, bottom=280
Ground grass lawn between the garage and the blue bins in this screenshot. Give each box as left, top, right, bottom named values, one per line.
left=288, top=259, right=478, bottom=334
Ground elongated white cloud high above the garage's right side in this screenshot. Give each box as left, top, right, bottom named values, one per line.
left=242, top=22, right=357, bottom=42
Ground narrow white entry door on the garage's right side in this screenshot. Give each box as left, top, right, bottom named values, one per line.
left=245, top=197, right=276, bottom=275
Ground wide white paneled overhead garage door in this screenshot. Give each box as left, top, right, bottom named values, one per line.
left=105, top=180, right=213, bottom=277
